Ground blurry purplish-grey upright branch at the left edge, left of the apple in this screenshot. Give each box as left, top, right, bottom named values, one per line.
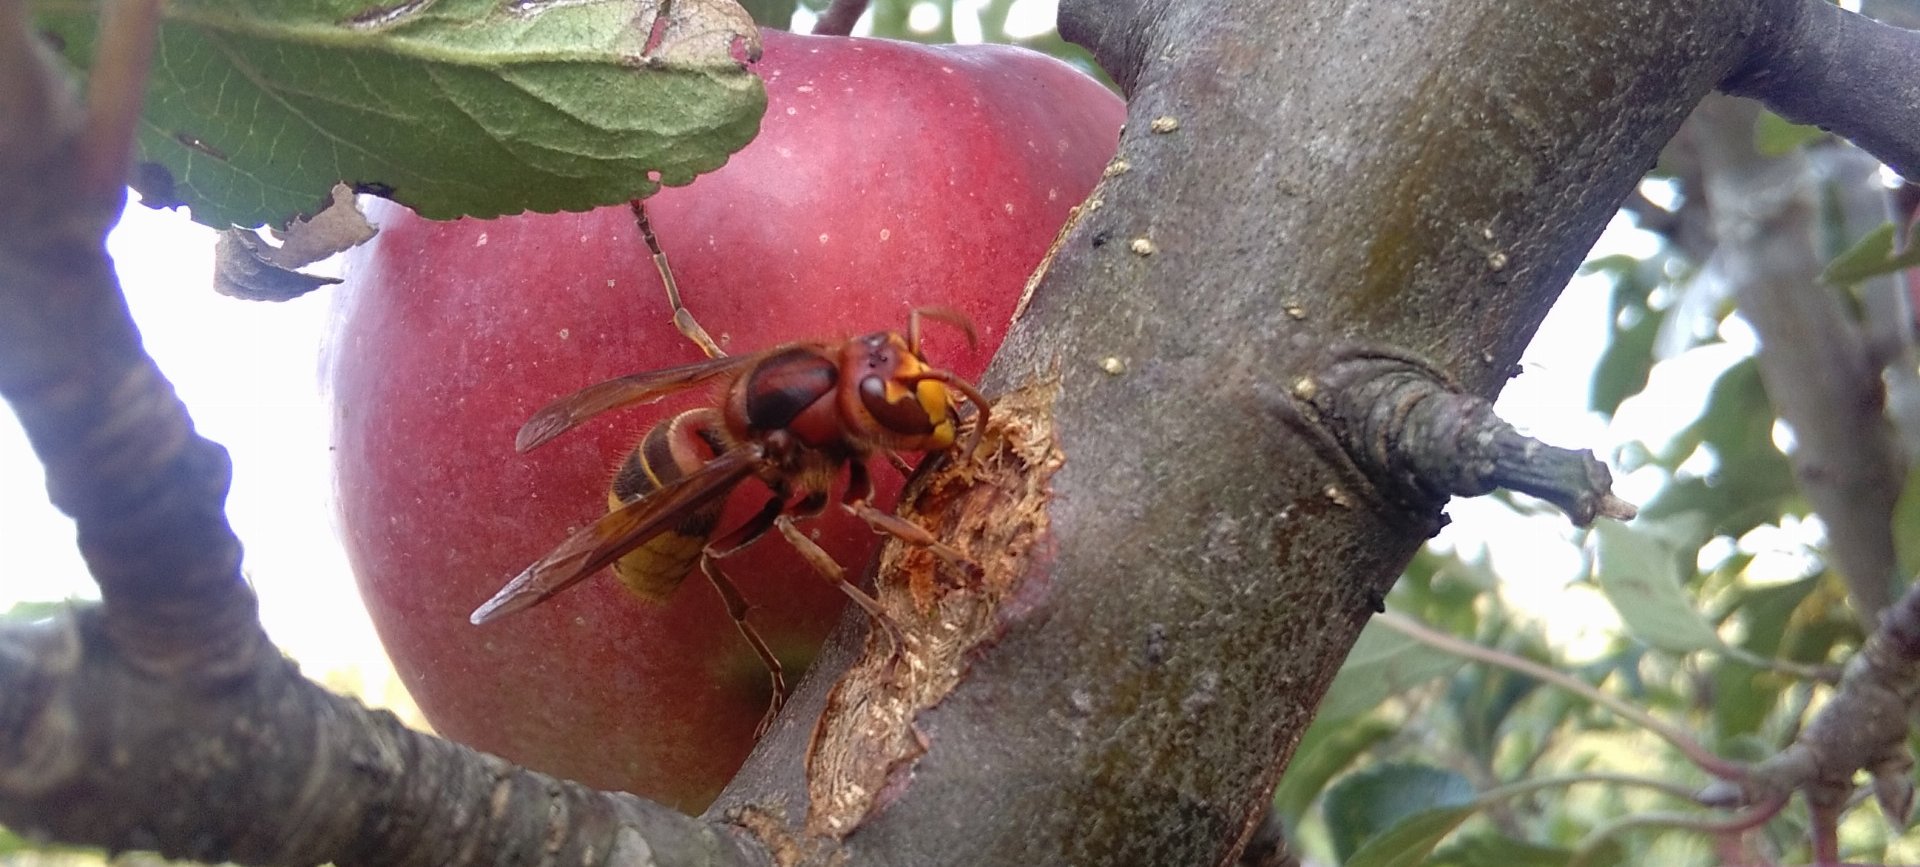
left=0, top=2, right=263, bottom=671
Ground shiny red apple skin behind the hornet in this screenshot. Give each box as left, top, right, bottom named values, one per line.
left=328, top=31, right=1123, bottom=811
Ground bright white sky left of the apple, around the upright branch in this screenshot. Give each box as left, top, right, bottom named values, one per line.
left=0, top=205, right=385, bottom=671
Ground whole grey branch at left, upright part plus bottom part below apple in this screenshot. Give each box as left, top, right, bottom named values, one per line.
left=0, top=0, right=739, bottom=865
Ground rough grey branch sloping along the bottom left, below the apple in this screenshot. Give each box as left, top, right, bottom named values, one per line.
left=0, top=608, right=741, bottom=867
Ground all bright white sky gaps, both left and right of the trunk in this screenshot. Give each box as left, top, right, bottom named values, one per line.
left=0, top=0, right=1738, bottom=692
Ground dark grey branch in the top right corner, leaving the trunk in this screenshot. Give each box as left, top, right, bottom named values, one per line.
left=1720, top=0, right=1920, bottom=178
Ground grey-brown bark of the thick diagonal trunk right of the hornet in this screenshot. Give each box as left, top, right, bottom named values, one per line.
left=716, top=0, right=1753, bottom=865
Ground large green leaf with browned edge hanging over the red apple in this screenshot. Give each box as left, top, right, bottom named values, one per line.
left=36, top=0, right=766, bottom=228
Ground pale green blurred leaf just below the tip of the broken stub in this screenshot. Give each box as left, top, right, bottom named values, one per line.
left=1594, top=522, right=1724, bottom=654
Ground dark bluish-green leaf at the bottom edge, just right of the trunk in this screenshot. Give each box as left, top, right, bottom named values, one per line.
left=1323, top=763, right=1475, bottom=867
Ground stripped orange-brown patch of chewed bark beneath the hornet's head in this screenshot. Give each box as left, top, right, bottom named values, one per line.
left=806, top=384, right=1064, bottom=838
